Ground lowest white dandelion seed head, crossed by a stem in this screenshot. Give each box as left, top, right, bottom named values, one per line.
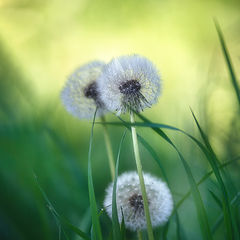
left=104, top=172, right=173, bottom=231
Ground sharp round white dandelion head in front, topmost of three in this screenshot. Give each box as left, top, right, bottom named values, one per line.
left=98, top=55, right=161, bottom=115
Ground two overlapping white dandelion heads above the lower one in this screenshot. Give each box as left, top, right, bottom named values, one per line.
left=61, top=55, right=160, bottom=119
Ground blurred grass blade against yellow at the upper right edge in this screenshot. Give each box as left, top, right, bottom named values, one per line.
left=214, top=20, right=240, bottom=106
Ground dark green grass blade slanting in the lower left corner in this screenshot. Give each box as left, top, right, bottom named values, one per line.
left=34, top=174, right=90, bottom=240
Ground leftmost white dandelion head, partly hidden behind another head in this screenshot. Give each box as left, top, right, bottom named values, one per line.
left=61, top=61, right=106, bottom=119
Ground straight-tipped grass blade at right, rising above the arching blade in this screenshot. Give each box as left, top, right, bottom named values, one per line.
left=191, top=110, right=233, bottom=239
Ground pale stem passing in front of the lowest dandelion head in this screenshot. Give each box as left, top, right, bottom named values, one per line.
left=130, top=111, right=154, bottom=240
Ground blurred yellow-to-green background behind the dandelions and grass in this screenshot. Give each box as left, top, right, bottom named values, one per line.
left=0, top=0, right=240, bottom=240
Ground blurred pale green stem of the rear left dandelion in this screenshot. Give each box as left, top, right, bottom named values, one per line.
left=101, top=116, right=115, bottom=180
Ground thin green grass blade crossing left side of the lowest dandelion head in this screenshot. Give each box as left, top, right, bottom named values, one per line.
left=112, top=130, right=126, bottom=240
